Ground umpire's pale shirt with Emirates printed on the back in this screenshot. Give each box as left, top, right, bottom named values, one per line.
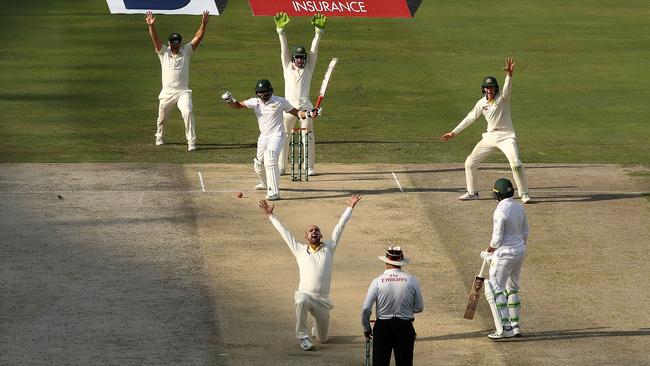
left=361, top=268, right=424, bottom=331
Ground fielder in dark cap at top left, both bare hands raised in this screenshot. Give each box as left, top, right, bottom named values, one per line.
left=145, top=11, right=210, bottom=151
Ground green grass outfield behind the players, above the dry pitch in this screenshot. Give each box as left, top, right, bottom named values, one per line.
left=0, top=0, right=650, bottom=164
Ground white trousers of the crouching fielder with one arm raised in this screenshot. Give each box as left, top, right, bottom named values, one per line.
left=465, top=131, right=528, bottom=196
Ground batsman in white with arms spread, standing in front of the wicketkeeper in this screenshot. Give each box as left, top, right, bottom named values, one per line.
left=221, top=79, right=319, bottom=201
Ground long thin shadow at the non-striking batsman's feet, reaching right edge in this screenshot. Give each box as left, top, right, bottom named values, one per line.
left=417, top=327, right=650, bottom=342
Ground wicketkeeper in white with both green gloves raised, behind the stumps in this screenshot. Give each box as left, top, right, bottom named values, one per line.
left=274, top=12, right=327, bottom=176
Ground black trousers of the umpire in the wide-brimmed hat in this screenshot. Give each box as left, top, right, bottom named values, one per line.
left=372, top=318, right=415, bottom=366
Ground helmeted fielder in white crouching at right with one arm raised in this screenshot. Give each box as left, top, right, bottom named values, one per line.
left=440, top=57, right=530, bottom=203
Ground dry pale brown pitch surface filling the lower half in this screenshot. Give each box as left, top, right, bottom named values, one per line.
left=0, top=164, right=650, bottom=365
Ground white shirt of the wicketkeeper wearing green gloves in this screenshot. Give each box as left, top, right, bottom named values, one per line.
left=278, top=30, right=321, bottom=109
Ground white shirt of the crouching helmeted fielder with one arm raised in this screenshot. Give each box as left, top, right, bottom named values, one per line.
left=453, top=76, right=515, bottom=135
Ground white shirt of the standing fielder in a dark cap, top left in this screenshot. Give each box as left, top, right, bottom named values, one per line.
left=158, top=43, right=194, bottom=98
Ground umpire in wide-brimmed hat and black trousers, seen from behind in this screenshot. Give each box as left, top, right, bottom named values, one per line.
left=361, top=245, right=424, bottom=366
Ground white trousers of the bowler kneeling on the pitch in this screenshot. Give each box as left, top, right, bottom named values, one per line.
left=293, top=291, right=332, bottom=343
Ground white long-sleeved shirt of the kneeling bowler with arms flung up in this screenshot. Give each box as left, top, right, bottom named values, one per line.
left=269, top=207, right=352, bottom=299
